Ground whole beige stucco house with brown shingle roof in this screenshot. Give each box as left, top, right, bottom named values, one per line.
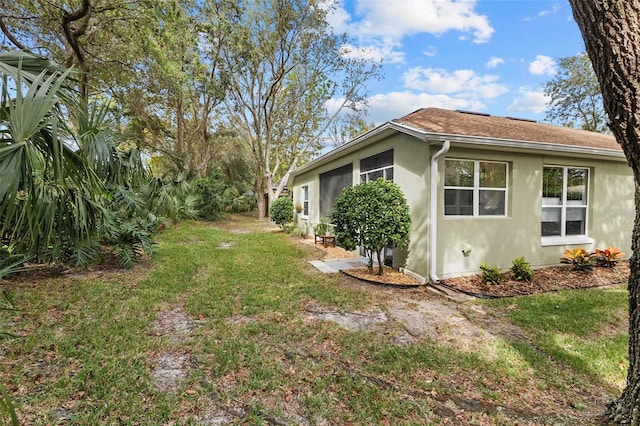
left=289, top=108, right=635, bottom=281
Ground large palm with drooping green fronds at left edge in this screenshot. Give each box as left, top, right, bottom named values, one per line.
left=0, top=52, right=104, bottom=261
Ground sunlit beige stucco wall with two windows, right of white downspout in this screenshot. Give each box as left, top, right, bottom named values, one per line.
left=432, top=148, right=635, bottom=278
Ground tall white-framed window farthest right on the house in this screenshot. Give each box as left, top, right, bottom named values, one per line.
left=541, top=166, right=589, bottom=244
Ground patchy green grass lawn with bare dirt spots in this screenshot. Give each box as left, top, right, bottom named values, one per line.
left=0, top=216, right=627, bottom=425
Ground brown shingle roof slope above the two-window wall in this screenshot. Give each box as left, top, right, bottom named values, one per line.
left=395, top=108, right=622, bottom=151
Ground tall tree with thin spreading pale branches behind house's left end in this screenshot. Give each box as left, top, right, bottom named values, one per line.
left=219, top=0, right=378, bottom=218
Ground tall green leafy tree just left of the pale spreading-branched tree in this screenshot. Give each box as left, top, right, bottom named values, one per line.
left=118, top=0, right=233, bottom=177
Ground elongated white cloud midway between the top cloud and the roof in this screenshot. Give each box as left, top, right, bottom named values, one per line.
left=402, top=67, right=509, bottom=99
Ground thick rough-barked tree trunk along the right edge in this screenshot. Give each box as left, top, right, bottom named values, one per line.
left=569, top=0, right=640, bottom=425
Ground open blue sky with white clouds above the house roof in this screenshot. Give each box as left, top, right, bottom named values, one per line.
left=330, top=0, right=585, bottom=125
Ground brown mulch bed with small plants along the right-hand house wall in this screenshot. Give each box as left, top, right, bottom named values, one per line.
left=441, top=261, right=629, bottom=298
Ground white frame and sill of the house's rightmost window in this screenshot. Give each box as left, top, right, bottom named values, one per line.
left=540, top=164, right=595, bottom=246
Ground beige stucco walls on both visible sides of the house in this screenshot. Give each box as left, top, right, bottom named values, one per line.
left=292, top=133, right=635, bottom=278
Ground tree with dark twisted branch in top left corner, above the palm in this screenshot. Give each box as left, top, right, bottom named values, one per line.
left=0, top=0, right=149, bottom=100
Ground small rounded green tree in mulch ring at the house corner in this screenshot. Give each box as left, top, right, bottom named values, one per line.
left=331, top=179, right=411, bottom=275
